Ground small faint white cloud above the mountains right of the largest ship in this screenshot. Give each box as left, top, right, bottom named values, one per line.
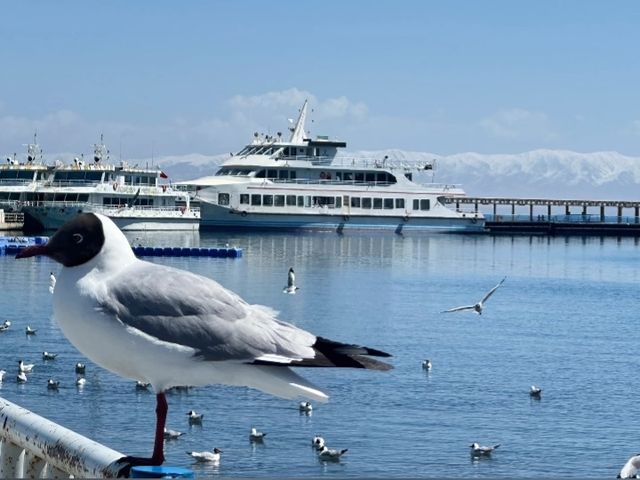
left=479, top=108, right=555, bottom=140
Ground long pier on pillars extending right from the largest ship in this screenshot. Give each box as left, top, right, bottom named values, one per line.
left=444, top=193, right=640, bottom=236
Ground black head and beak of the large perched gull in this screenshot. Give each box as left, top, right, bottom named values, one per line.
left=16, top=213, right=105, bottom=267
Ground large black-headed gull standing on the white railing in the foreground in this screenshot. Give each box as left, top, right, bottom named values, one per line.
left=16, top=213, right=392, bottom=475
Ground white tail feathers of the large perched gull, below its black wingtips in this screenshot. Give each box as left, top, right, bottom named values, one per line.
left=250, top=365, right=329, bottom=403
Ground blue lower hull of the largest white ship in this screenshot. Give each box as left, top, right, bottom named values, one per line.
left=200, top=202, right=484, bottom=233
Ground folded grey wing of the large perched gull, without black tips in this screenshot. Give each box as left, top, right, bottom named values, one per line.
left=96, top=261, right=316, bottom=362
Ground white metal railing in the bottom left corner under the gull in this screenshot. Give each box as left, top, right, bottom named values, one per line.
left=0, top=398, right=124, bottom=478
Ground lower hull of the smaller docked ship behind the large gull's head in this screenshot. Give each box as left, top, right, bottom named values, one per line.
left=23, top=206, right=200, bottom=231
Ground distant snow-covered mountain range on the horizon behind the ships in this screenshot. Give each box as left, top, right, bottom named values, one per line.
left=145, top=150, right=640, bottom=200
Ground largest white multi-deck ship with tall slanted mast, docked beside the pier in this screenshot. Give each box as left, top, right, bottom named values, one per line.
left=180, top=101, right=484, bottom=232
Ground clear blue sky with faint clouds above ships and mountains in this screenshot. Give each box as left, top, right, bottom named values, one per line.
left=0, top=0, right=640, bottom=158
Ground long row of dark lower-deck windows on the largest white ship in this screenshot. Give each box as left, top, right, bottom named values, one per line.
left=218, top=193, right=431, bottom=210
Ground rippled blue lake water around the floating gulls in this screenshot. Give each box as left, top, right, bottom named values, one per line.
left=0, top=233, right=640, bottom=478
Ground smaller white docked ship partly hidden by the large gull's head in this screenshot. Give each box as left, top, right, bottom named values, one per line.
left=22, top=137, right=200, bottom=230
